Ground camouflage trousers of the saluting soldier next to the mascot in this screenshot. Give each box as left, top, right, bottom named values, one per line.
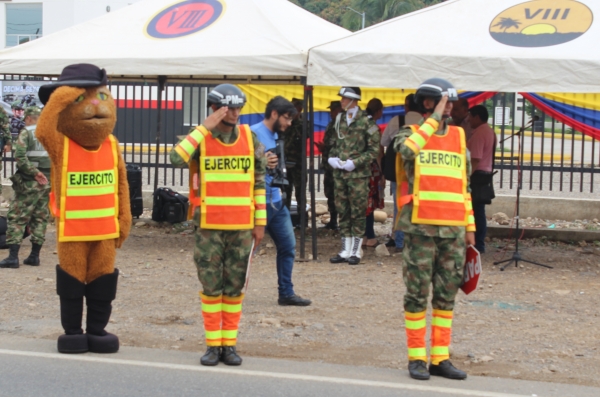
left=194, top=228, right=252, bottom=297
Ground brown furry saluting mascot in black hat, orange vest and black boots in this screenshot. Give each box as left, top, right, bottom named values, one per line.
left=36, top=64, right=131, bottom=353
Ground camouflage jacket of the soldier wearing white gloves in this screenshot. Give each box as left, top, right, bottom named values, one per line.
left=329, top=106, right=380, bottom=179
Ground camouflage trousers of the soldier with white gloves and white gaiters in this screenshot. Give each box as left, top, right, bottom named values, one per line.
left=334, top=175, right=369, bottom=238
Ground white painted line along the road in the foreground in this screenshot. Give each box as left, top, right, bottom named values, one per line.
left=0, top=349, right=526, bottom=397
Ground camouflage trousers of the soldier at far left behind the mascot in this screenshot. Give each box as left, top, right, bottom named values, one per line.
left=6, top=181, right=50, bottom=245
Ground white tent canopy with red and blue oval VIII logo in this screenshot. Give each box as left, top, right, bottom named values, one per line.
left=0, top=0, right=350, bottom=84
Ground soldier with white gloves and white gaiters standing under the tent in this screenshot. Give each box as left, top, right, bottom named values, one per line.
left=328, top=87, right=379, bottom=265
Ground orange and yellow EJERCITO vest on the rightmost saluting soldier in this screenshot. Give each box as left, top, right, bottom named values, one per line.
left=396, top=125, right=472, bottom=226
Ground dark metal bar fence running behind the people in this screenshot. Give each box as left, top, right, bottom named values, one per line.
left=0, top=76, right=600, bottom=197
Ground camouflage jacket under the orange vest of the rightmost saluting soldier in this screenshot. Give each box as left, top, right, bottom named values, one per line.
left=392, top=113, right=471, bottom=238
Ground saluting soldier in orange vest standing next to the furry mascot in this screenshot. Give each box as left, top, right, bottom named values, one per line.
left=170, top=84, right=267, bottom=365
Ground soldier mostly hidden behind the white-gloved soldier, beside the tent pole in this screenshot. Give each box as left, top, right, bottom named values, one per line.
left=317, top=101, right=342, bottom=230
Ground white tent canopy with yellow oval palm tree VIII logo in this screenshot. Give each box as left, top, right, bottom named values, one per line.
left=308, top=0, right=600, bottom=92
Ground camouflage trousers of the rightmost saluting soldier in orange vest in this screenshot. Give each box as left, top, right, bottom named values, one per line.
left=402, top=233, right=466, bottom=313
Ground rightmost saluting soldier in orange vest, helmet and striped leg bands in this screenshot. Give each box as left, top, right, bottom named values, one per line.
left=392, top=78, right=475, bottom=380
